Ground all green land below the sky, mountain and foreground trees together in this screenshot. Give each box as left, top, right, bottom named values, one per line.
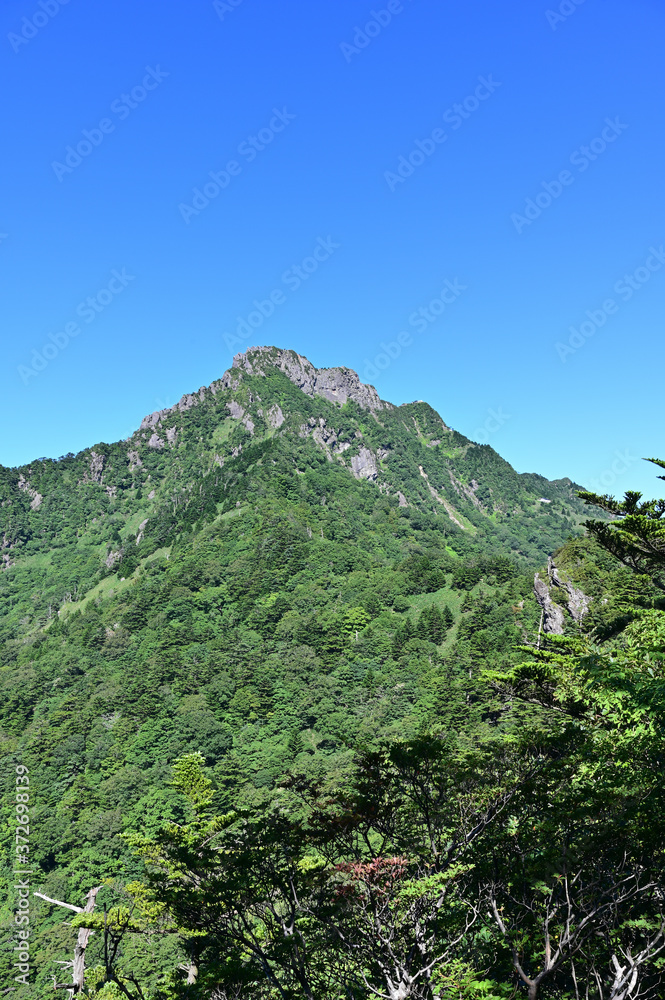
left=0, top=348, right=665, bottom=1000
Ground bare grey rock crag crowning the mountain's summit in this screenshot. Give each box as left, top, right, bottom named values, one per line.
left=232, top=347, right=392, bottom=413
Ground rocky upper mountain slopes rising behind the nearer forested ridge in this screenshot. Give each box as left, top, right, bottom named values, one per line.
left=0, top=347, right=584, bottom=636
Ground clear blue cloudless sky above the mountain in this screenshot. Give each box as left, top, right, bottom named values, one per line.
left=0, top=0, right=665, bottom=494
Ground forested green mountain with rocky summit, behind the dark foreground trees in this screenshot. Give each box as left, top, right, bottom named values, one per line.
left=0, top=347, right=596, bottom=1000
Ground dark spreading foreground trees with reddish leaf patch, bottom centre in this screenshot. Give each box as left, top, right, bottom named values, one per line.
left=135, top=735, right=537, bottom=1000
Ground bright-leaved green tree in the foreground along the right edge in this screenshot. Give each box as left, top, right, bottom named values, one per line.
left=478, top=462, right=665, bottom=1000
